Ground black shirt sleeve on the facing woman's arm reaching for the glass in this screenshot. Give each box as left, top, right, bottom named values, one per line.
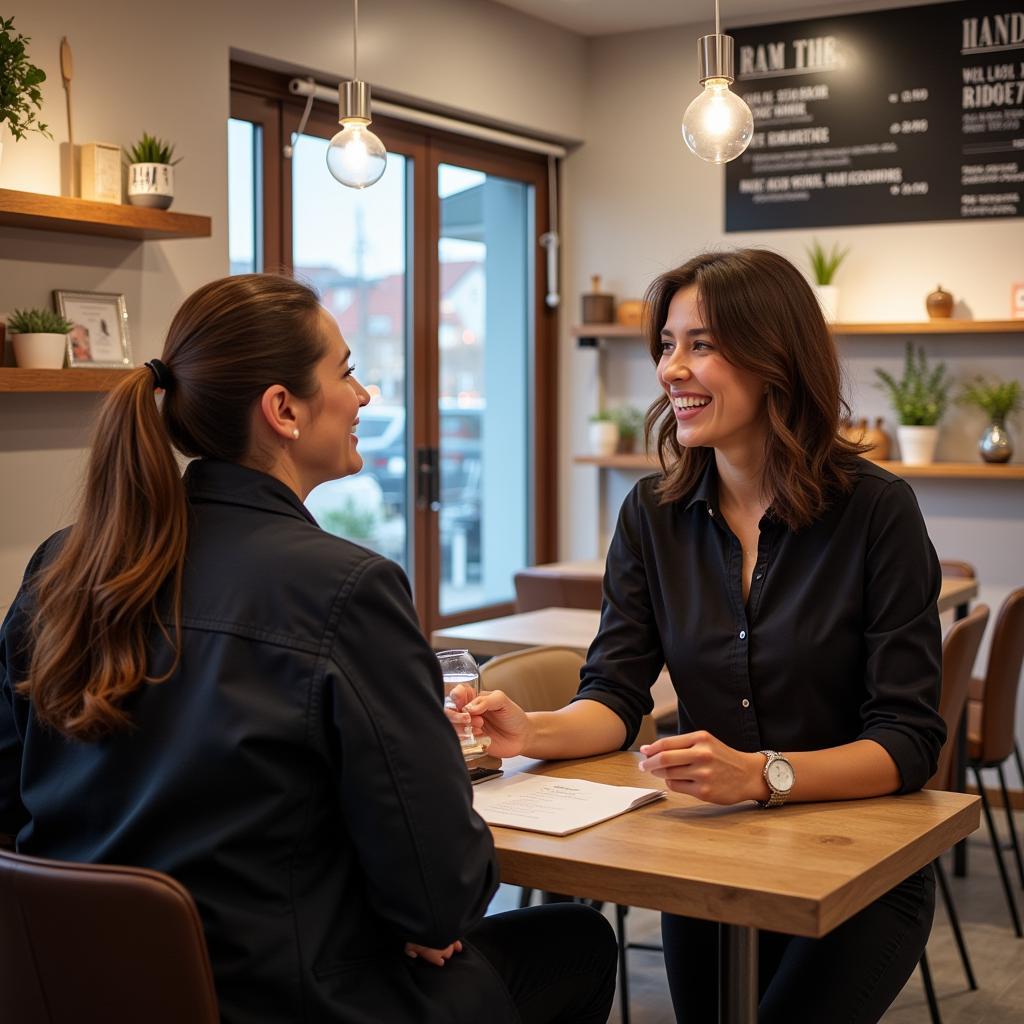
left=573, top=481, right=665, bottom=750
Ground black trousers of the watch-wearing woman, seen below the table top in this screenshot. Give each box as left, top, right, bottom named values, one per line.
left=662, top=864, right=935, bottom=1024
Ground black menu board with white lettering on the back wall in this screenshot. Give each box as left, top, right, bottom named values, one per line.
left=725, top=0, right=1024, bottom=231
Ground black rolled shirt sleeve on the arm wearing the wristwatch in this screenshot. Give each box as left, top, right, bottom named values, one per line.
left=858, top=480, right=946, bottom=793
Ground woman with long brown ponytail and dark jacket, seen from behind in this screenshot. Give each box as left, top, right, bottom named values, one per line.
left=0, top=274, right=614, bottom=1024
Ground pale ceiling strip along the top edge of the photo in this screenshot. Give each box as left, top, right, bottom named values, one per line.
left=494, top=0, right=950, bottom=36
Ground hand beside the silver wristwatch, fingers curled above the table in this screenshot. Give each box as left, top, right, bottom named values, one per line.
left=640, top=729, right=769, bottom=804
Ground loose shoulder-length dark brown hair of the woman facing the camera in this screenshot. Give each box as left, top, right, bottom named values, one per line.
left=644, top=249, right=865, bottom=529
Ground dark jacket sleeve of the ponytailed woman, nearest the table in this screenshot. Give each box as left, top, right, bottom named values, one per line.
left=322, top=558, right=498, bottom=948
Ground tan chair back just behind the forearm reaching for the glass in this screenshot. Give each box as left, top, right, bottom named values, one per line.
left=480, top=647, right=656, bottom=749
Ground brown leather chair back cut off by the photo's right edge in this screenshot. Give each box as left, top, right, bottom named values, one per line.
left=969, top=587, right=1024, bottom=764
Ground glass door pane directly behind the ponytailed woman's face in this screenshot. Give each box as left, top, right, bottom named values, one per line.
left=292, top=135, right=411, bottom=571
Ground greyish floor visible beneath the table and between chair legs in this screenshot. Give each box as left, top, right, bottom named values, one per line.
left=495, top=811, right=1024, bottom=1024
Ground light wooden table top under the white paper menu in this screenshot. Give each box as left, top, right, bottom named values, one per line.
left=484, top=752, right=980, bottom=938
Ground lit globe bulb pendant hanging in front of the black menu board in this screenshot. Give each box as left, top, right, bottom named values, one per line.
left=683, top=0, right=754, bottom=164
